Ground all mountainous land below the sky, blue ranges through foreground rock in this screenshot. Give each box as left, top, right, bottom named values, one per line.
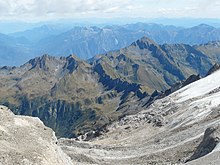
left=0, top=20, right=220, bottom=165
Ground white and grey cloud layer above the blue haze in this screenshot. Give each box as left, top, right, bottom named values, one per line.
left=0, top=0, right=220, bottom=21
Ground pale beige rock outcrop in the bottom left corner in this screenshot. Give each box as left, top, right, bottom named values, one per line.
left=0, top=106, right=72, bottom=165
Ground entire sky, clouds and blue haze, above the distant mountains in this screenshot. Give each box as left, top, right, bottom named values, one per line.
left=0, top=0, right=220, bottom=34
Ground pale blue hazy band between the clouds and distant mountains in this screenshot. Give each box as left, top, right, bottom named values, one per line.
left=0, top=17, right=220, bottom=34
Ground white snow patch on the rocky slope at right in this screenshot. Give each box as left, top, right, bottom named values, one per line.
left=170, top=70, right=220, bottom=125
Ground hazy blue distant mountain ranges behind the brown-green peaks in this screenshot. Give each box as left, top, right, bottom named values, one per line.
left=0, top=23, right=220, bottom=66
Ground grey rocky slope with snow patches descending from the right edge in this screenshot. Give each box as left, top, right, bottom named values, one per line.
left=59, top=67, right=220, bottom=165
